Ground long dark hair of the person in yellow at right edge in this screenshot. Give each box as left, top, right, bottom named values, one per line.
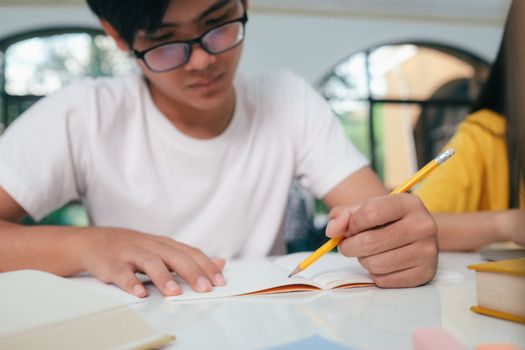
left=472, top=0, right=525, bottom=208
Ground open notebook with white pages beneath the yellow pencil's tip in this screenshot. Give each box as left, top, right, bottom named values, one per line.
left=166, top=252, right=374, bottom=301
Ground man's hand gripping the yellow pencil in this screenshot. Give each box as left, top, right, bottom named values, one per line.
left=326, top=193, right=438, bottom=288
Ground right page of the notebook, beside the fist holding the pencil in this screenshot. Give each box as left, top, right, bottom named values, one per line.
left=274, top=252, right=373, bottom=289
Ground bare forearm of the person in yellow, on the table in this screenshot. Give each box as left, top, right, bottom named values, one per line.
left=434, top=209, right=525, bottom=251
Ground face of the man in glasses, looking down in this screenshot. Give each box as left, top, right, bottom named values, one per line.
left=133, top=0, right=244, bottom=111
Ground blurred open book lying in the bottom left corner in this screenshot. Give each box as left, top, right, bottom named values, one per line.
left=0, top=270, right=174, bottom=349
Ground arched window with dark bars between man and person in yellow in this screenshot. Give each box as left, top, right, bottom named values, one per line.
left=318, top=42, right=489, bottom=188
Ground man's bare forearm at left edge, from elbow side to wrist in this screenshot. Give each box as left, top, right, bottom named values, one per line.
left=0, top=220, right=86, bottom=276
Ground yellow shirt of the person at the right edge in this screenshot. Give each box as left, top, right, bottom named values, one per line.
left=414, top=110, right=525, bottom=213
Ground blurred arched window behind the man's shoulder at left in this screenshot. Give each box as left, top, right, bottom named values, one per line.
left=0, top=28, right=135, bottom=226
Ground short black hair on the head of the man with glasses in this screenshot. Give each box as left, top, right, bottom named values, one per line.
left=87, top=0, right=170, bottom=48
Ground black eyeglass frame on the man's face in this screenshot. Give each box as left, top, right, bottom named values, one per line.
left=131, top=10, right=248, bottom=73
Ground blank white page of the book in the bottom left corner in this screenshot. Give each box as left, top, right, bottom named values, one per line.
left=0, top=270, right=124, bottom=337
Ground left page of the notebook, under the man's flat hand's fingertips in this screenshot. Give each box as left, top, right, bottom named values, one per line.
left=166, top=258, right=320, bottom=301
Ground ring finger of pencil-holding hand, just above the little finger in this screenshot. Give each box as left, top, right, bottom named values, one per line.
left=358, top=240, right=437, bottom=275
